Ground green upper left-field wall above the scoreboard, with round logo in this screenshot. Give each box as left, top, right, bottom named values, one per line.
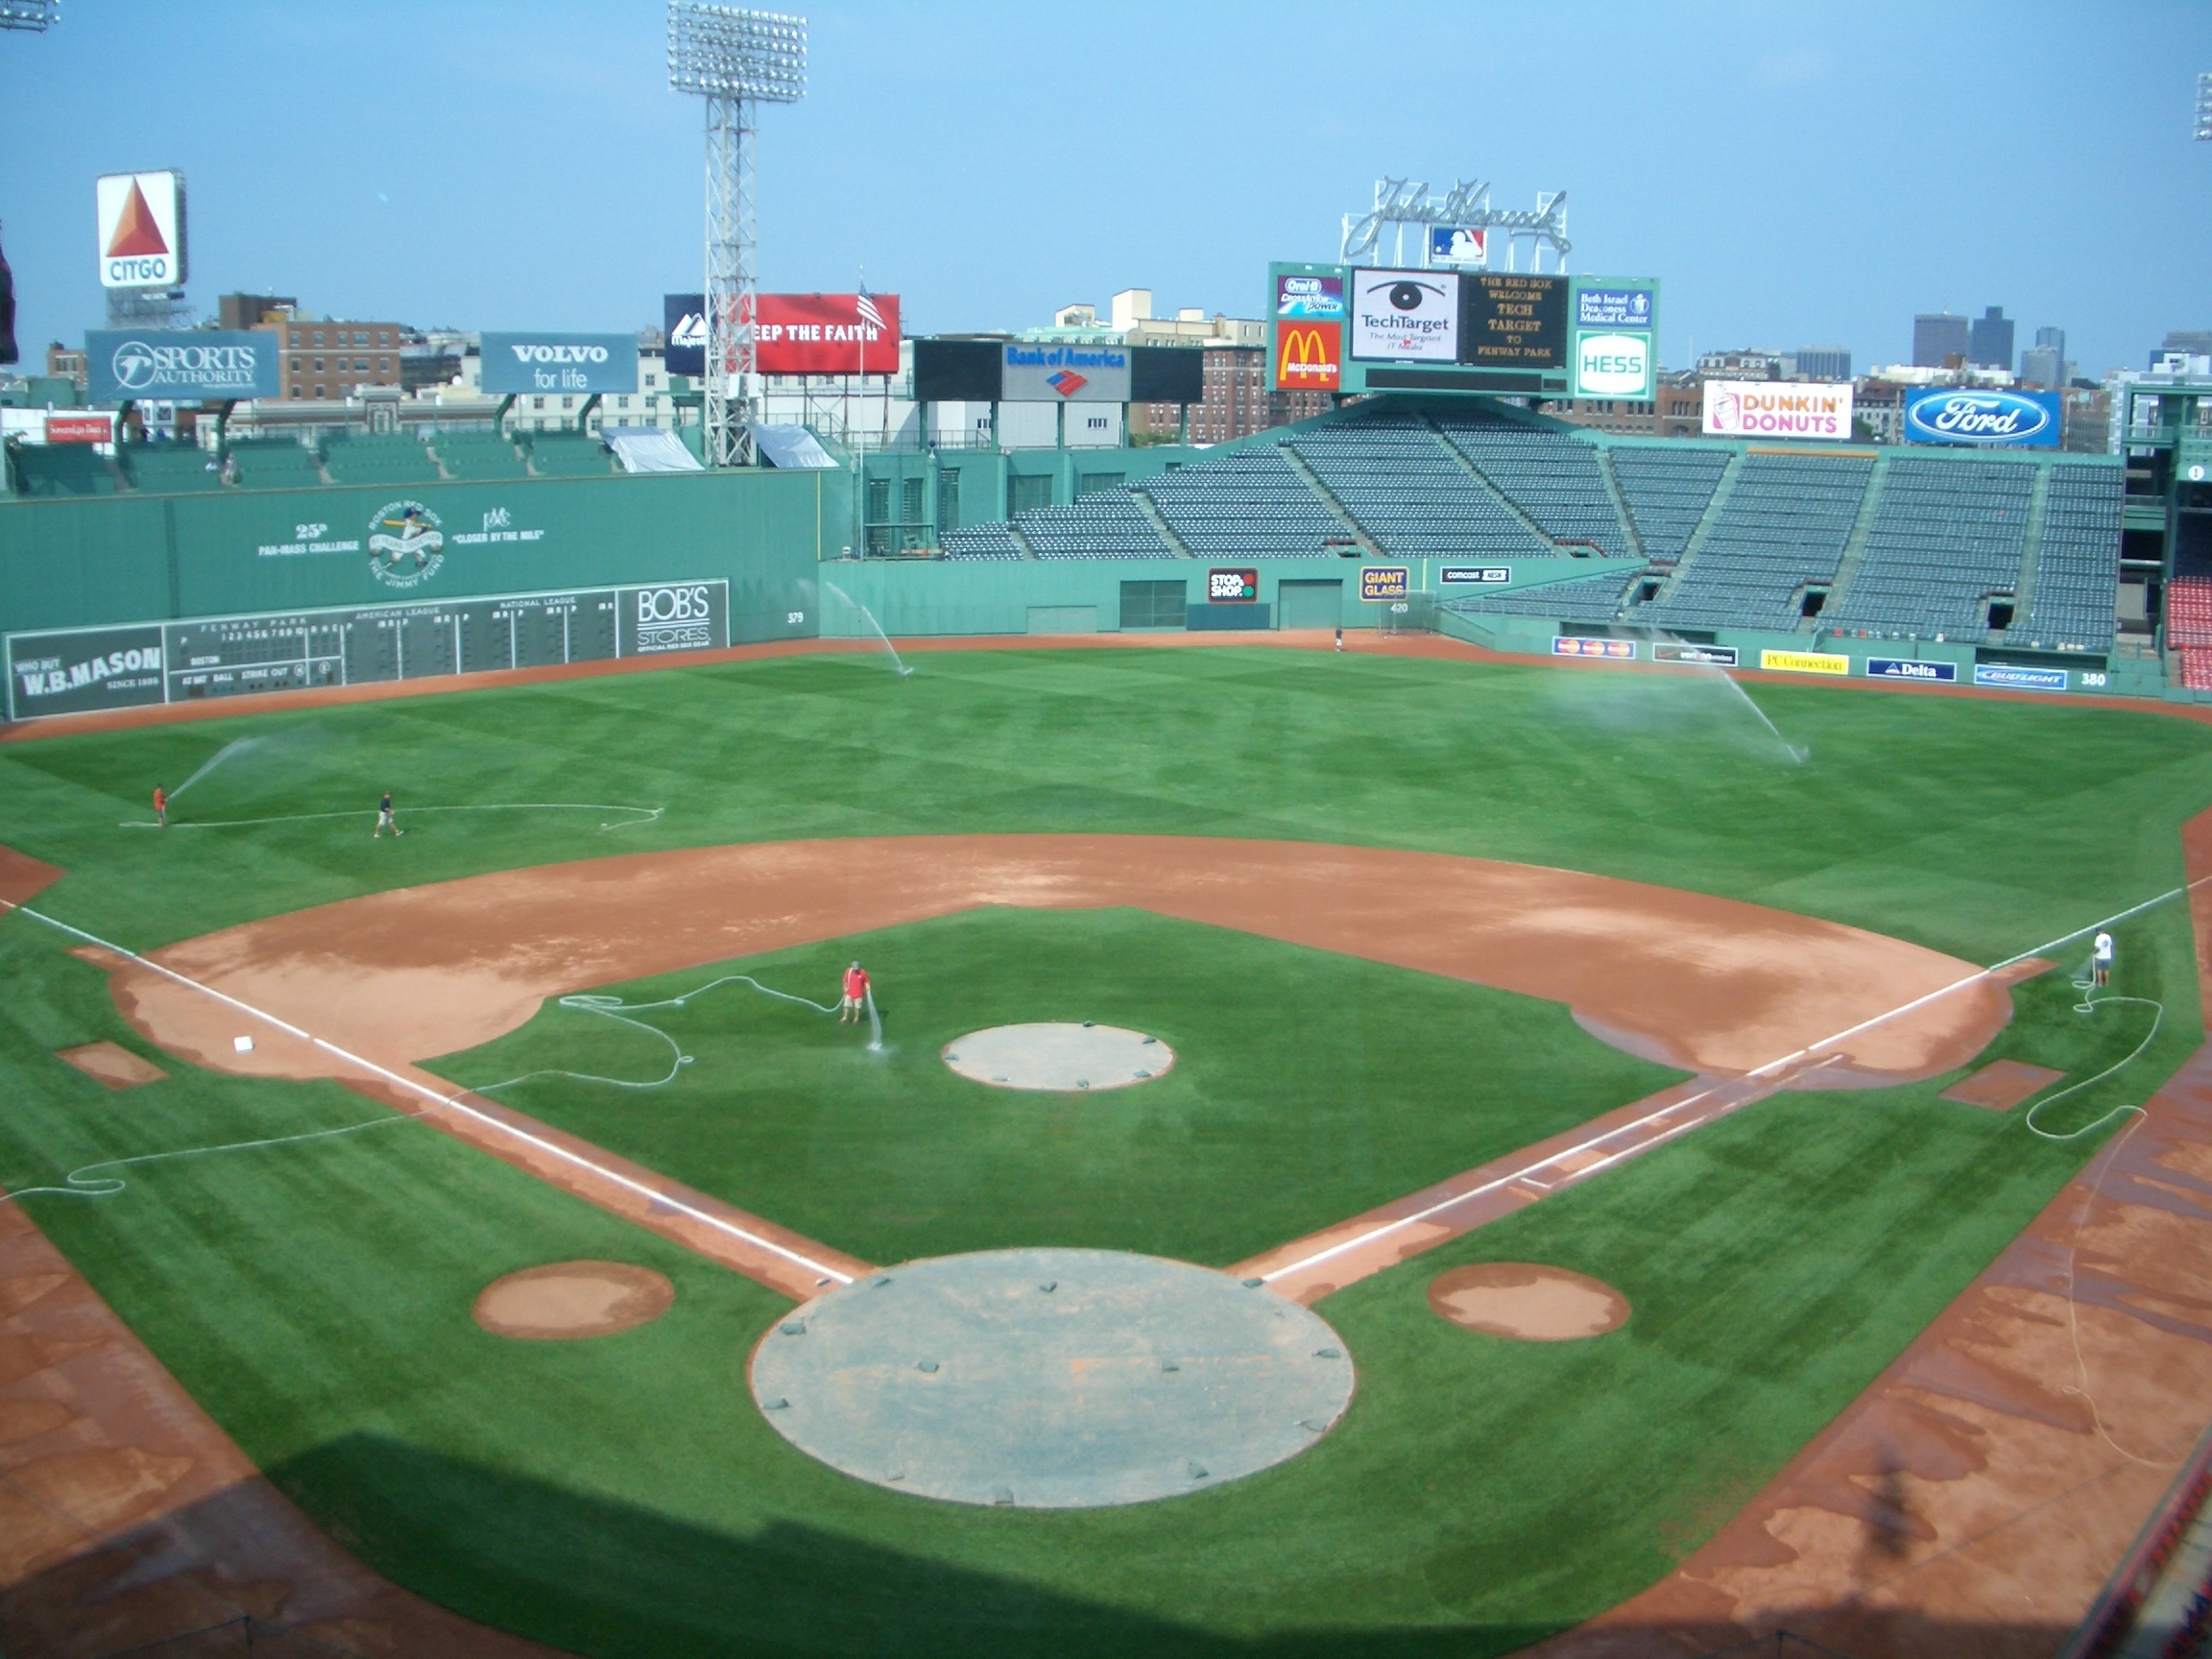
left=0, top=471, right=852, bottom=641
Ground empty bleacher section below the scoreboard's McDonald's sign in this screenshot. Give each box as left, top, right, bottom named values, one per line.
left=1283, top=414, right=1557, bottom=560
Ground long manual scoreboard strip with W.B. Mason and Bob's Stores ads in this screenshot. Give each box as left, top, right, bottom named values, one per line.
left=7, top=580, right=730, bottom=719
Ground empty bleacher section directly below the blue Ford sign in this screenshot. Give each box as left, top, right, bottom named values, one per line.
left=1820, top=456, right=2034, bottom=643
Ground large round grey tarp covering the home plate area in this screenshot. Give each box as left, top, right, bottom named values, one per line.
left=752, top=1250, right=1352, bottom=1508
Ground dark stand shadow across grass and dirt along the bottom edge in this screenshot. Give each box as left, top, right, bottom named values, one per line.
left=0, top=1435, right=2066, bottom=1659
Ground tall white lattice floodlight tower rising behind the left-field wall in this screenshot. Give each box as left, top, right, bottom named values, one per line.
left=668, top=0, right=807, bottom=467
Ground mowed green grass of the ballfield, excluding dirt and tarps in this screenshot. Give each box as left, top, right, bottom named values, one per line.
left=0, top=650, right=2212, bottom=1654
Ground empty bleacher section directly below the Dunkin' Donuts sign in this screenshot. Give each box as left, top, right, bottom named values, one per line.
left=1630, top=451, right=1873, bottom=633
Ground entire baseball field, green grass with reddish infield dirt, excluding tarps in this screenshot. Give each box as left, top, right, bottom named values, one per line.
left=0, top=646, right=2212, bottom=1657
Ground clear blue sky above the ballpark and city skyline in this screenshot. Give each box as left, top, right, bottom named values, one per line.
left=0, top=0, right=2212, bottom=373
